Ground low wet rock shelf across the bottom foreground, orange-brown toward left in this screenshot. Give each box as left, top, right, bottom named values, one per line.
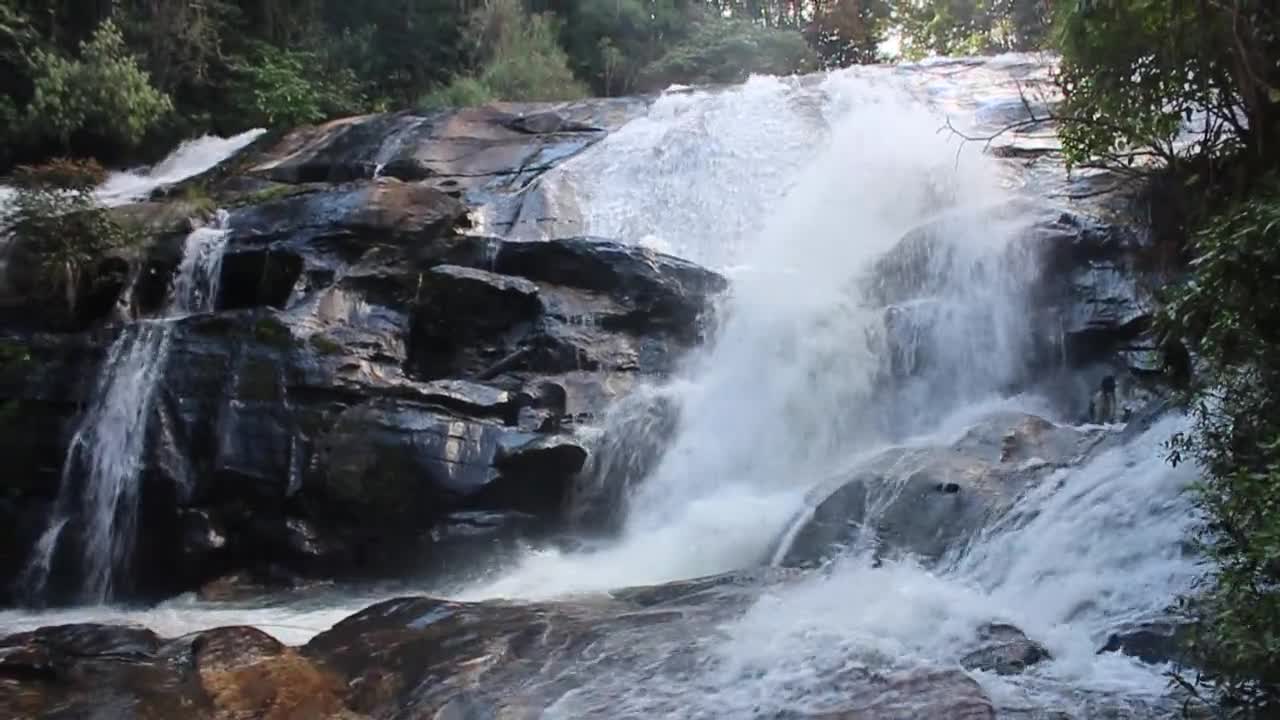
left=0, top=574, right=996, bottom=720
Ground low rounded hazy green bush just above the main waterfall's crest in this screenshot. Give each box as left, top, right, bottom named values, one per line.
left=641, top=19, right=818, bottom=88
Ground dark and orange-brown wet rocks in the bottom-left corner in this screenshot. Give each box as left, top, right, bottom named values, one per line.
left=0, top=625, right=360, bottom=720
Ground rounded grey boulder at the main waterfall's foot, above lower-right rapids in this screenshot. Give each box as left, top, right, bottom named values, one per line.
left=774, top=413, right=1101, bottom=566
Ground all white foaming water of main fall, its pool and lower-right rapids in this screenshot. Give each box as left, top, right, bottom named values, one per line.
left=0, top=55, right=1197, bottom=717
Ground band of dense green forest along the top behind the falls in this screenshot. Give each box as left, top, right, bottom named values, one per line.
left=0, top=0, right=1048, bottom=172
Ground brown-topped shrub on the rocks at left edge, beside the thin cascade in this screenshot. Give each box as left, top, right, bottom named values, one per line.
left=0, top=161, right=136, bottom=311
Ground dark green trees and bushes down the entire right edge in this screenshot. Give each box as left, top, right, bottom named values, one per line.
left=1059, top=0, right=1280, bottom=717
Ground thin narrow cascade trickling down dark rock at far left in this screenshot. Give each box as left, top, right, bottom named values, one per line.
left=23, top=211, right=230, bottom=603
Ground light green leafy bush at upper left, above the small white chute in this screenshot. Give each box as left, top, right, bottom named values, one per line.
left=26, top=20, right=173, bottom=146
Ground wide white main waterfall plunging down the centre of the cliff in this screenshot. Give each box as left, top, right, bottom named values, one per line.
left=468, top=68, right=1049, bottom=597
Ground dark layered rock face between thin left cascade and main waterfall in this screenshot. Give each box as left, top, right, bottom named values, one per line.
left=0, top=102, right=727, bottom=602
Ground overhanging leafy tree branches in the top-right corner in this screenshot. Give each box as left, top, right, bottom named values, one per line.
left=1057, top=0, right=1280, bottom=168
